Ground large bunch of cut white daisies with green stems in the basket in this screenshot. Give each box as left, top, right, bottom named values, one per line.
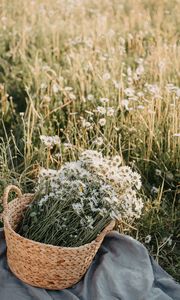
left=17, top=150, right=143, bottom=247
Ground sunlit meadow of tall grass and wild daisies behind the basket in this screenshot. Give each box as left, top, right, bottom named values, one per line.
left=0, top=0, right=180, bottom=280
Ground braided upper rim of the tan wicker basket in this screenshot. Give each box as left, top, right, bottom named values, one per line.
left=3, top=193, right=116, bottom=250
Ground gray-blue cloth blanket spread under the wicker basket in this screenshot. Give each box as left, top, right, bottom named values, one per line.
left=0, top=230, right=180, bottom=300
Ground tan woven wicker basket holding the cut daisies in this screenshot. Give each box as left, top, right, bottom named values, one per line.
left=3, top=185, right=115, bottom=290
